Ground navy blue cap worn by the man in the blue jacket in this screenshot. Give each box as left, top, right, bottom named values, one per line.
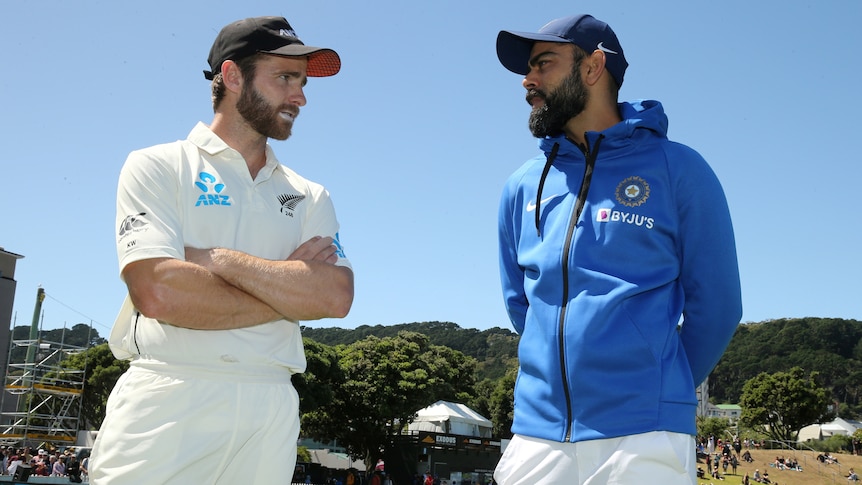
left=497, top=15, right=629, bottom=86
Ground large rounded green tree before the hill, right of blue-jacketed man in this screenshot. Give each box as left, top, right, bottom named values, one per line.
left=740, top=367, right=830, bottom=441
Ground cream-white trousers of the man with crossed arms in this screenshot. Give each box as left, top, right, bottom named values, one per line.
left=89, top=365, right=299, bottom=485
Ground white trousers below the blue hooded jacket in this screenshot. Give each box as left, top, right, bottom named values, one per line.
left=494, top=431, right=697, bottom=485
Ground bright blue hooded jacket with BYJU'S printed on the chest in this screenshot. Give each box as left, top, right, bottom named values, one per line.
left=499, top=101, right=742, bottom=442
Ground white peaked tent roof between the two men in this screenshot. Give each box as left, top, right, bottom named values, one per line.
left=407, top=401, right=493, bottom=438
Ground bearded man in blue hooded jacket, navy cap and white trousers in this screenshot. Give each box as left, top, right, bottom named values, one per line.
left=495, top=15, right=742, bottom=485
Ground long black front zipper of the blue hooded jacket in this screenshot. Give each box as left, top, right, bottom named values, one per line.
left=558, top=134, right=604, bottom=442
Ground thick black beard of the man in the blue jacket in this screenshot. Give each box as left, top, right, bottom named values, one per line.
left=527, top=63, right=588, bottom=138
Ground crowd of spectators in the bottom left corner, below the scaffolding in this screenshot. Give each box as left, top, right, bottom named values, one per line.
left=0, top=446, right=89, bottom=483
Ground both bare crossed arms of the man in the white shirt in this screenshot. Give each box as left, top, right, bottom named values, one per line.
left=123, top=237, right=353, bottom=330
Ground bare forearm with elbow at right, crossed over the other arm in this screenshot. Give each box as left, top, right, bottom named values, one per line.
left=199, top=248, right=353, bottom=320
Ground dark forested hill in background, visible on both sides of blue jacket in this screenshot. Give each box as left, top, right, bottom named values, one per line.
left=302, top=317, right=862, bottom=419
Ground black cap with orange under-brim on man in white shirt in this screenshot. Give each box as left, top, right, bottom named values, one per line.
left=204, top=17, right=341, bottom=80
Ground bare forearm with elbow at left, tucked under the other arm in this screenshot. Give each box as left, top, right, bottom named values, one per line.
left=123, top=258, right=283, bottom=330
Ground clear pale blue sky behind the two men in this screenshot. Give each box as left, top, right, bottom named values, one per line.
left=0, top=0, right=862, bottom=336
